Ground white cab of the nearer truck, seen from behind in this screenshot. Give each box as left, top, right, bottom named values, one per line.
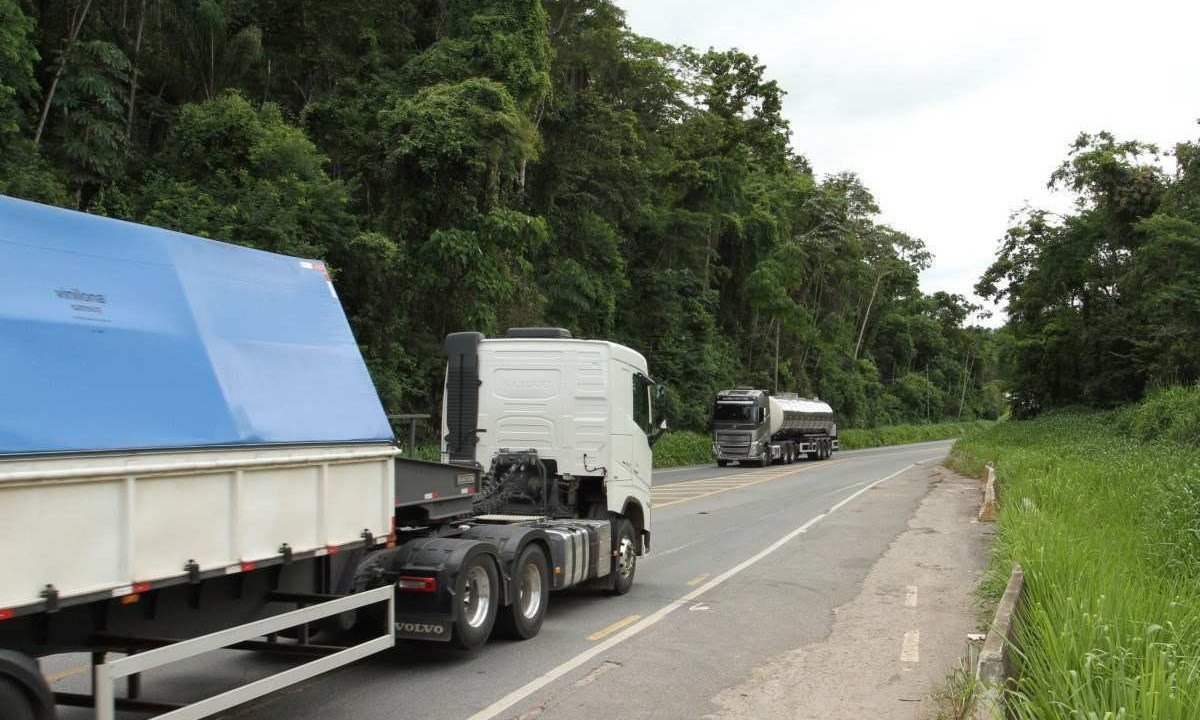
left=442, top=328, right=666, bottom=563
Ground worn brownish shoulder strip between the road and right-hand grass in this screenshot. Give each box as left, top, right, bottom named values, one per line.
left=708, top=466, right=991, bottom=720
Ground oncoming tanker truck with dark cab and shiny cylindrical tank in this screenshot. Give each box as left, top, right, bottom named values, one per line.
left=713, top=388, right=838, bottom=467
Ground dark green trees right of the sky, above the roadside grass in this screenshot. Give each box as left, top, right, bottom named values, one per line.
left=977, top=133, right=1200, bottom=416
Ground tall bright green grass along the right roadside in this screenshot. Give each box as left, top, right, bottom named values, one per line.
left=952, top=390, right=1200, bottom=720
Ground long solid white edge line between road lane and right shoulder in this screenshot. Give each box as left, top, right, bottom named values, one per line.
left=467, top=464, right=914, bottom=720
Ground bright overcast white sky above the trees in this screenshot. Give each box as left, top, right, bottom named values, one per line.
left=618, top=0, right=1200, bottom=322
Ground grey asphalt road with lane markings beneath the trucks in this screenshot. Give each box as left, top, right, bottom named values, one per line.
left=46, top=442, right=950, bottom=720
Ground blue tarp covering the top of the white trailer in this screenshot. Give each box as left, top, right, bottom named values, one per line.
left=0, top=190, right=392, bottom=454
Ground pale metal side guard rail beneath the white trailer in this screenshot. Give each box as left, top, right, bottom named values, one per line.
left=81, top=586, right=396, bottom=720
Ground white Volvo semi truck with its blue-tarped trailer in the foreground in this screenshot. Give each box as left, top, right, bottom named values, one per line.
left=0, top=197, right=665, bottom=720
